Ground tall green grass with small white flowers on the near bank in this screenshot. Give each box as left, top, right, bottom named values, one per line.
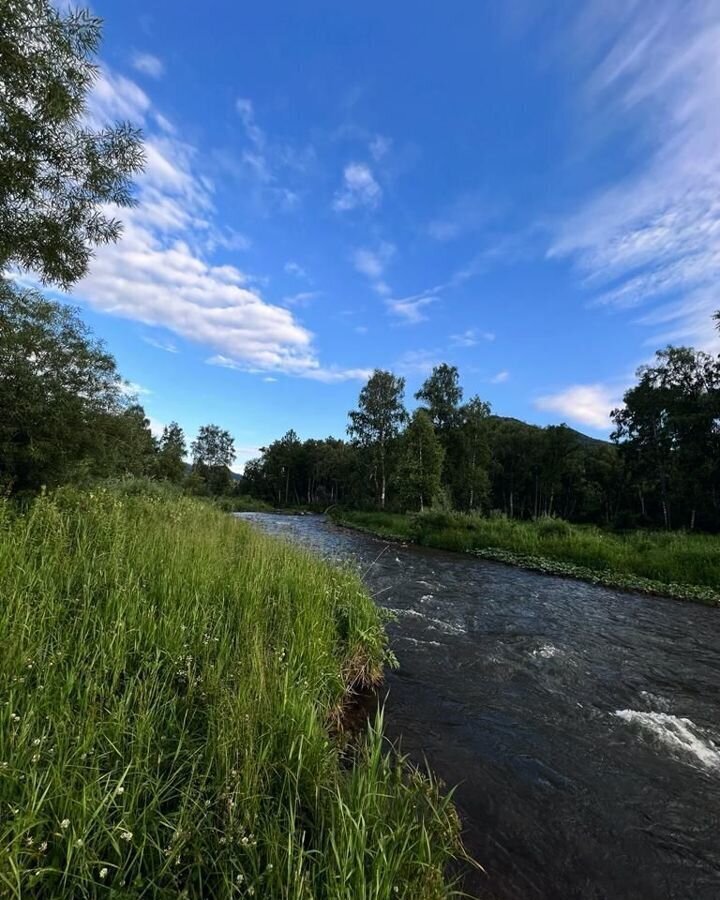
left=0, top=491, right=458, bottom=900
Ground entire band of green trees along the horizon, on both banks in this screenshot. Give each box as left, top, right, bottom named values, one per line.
left=5, top=280, right=720, bottom=531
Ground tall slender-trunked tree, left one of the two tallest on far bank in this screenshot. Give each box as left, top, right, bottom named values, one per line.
left=348, top=369, right=407, bottom=509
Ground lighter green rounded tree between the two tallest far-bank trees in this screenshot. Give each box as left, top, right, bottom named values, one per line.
left=399, top=409, right=444, bottom=512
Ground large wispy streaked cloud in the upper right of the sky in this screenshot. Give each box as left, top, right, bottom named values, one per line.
left=550, top=0, right=720, bottom=347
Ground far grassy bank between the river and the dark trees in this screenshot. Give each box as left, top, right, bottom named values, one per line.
left=332, top=510, right=720, bottom=605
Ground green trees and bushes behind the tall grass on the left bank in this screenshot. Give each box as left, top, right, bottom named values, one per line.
left=0, top=280, right=235, bottom=498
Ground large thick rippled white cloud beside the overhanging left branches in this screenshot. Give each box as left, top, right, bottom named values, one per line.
left=59, top=69, right=365, bottom=382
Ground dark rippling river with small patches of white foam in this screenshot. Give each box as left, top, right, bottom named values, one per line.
left=238, top=514, right=720, bottom=900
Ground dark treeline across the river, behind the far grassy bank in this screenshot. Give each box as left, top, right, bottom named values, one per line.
left=241, top=347, right=720, bottom=531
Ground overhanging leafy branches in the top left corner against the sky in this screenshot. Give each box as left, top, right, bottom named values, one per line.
left=0, top=0, right=144, bottom=286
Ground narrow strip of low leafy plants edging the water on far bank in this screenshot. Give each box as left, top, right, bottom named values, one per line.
left=326, top=515, right=720, bottom=608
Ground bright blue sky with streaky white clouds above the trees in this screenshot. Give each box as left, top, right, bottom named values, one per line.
left=57, top=0, right=720, bottom=465
